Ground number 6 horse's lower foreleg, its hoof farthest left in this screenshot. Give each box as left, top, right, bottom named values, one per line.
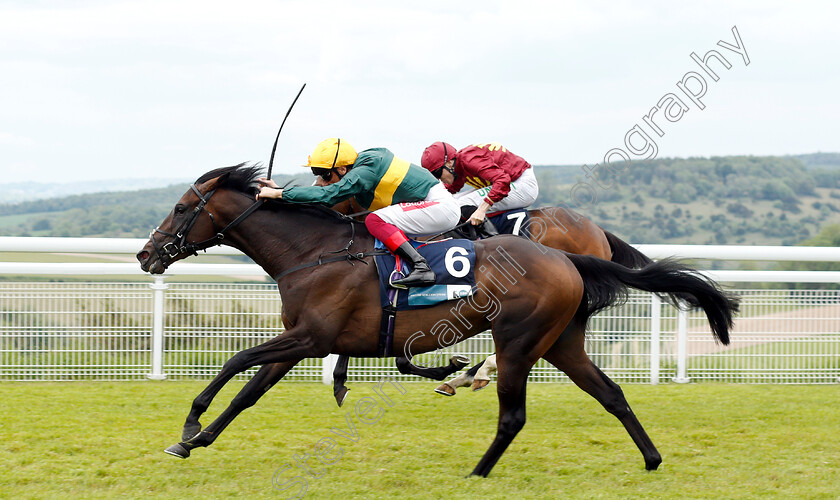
left=164, top=361, right=298, bottom=458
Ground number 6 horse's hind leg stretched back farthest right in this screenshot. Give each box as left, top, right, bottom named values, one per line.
left=543, top=331, right=662, bottom=470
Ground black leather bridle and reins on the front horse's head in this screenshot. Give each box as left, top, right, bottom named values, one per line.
left=149, top=184, right=265, bottom=269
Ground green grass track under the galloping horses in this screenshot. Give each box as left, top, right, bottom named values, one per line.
left=0, top=381, right=840, bottom=499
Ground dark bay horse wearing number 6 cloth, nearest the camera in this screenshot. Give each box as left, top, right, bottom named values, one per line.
left=137, top=164, right=738, bottom=477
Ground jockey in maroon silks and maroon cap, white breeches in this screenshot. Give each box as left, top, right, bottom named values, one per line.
left=421, top=142, right=539, bottom=234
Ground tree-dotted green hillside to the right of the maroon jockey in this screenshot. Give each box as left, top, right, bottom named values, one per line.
left=536, top=154, right=840, bottom=245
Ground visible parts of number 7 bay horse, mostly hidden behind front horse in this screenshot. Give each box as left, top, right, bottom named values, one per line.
left=324, top=193, right=668, bottom=407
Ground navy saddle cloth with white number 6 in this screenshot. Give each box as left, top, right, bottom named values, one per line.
left=375, top=239, right=475, bottom=311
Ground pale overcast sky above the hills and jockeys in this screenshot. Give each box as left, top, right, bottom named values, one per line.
left=0, top=0, right=840, bottom=183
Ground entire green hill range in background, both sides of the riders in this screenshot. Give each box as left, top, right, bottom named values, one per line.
left=0, top=153, right=840, bottom=245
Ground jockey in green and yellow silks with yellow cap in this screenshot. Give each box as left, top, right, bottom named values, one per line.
left=257, top=138, right=460, bottom=287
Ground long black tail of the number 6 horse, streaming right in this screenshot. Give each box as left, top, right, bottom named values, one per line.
left=566, top=254, right=738, bottom=345
